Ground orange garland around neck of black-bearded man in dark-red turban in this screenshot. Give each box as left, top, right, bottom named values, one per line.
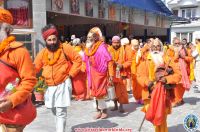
left=44, top=44, right=62, bottom=66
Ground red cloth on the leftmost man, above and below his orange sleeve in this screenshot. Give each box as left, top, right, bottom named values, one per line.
left=0, top=59, right=36, bottom=125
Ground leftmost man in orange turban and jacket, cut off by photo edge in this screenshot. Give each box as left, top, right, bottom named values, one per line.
left=0, top=9, right=36, bottom=132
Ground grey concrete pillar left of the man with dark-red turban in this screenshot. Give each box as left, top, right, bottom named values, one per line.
left=32, top=0, right=47, bottom=55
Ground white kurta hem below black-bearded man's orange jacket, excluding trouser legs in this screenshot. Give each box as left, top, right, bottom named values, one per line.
left=44, top=78, right=72, bottom=108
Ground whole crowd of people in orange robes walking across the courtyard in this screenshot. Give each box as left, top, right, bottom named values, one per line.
left=0, top=9, right=200, bottom=132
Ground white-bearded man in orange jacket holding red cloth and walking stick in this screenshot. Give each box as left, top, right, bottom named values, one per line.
left=136, top=38, right=181, bottom=132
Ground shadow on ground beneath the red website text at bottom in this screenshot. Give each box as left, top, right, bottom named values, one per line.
left=71, top=120, right=118, bottom=132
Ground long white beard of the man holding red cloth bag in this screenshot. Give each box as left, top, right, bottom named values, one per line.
left=151, top=51, right=164, bottom=67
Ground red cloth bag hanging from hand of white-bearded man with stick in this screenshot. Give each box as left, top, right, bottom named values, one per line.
left=146, top=82, right=167, bottom=126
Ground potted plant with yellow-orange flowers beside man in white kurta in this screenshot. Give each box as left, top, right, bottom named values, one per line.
left=34, top=77, right=48, bottom=101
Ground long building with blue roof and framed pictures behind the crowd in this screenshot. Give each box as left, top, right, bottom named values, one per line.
left=0, top=0, right=171, bottom=58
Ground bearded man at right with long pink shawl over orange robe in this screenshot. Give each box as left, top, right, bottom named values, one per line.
left=167, top=38, right=192, bottom=107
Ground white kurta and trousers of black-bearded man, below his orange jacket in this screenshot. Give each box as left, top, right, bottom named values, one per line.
left=45, top=78, right=72, bottom=132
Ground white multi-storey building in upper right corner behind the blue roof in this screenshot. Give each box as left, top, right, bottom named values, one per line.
left=167, top=0, right=200, bottom=43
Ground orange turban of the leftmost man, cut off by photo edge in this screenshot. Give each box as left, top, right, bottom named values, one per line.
left=0, top=8, right=13, bottom=24
